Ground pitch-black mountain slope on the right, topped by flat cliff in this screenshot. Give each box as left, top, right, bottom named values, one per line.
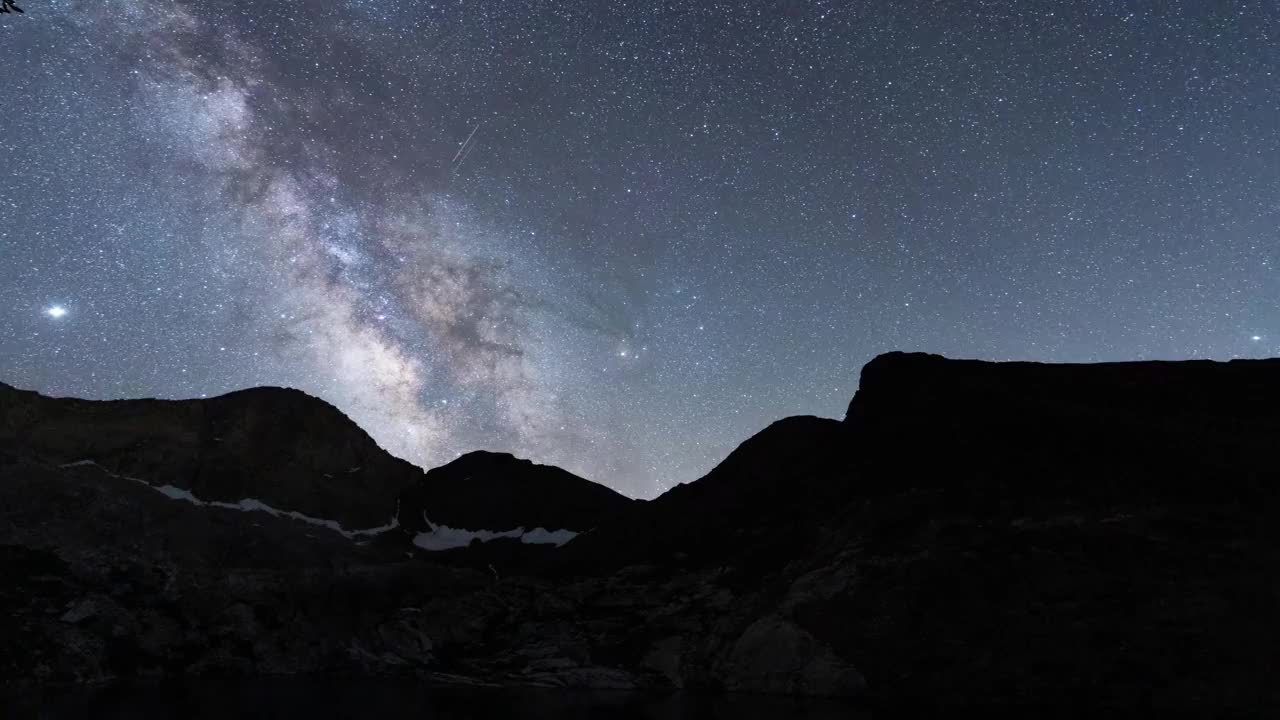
left=559, top=354, right=1280, bottom=708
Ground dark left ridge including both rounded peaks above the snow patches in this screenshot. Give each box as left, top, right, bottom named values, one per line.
left=0, top=384, right=631, bottom=534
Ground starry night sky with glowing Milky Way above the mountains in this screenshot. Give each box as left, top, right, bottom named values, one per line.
left=0, top=0, right=1280, bottom=497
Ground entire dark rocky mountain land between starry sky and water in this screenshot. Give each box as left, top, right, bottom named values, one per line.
left=0, top=354, right=1280, bottom=714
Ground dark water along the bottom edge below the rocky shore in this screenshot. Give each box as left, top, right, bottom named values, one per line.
left=4, top=679, right=870, bottom=720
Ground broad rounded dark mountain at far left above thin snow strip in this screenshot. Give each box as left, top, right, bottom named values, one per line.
left=0, top=386, right=412, bottom=528
